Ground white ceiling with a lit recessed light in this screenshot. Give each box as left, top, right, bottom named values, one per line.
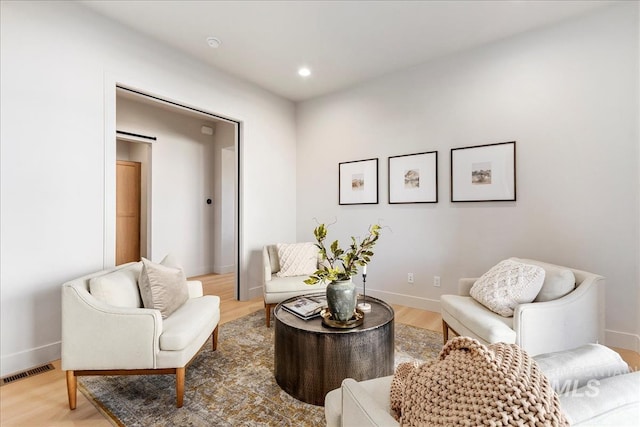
left=82, top=0, right=616, bottom=101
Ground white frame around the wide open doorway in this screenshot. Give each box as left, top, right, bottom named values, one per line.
left=103, top=81, right=242, bottom=299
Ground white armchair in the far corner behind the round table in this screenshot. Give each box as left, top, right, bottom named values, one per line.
left=262, top=245, right=327, bottom=327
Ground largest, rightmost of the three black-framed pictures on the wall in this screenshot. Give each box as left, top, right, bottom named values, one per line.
left=451, top=141, right=516, bottom=202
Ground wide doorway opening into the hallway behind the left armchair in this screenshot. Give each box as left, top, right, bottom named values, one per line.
left=106, top=84, right=241, bottom=299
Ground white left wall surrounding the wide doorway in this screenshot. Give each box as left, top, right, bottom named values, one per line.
left=0, top=2, right=296, bottom=376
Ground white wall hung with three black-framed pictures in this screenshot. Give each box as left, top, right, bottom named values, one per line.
left=297, top=2, right=640, bottom=351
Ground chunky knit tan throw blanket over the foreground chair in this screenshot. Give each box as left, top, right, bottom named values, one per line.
left=391, top=337, right=569, bottom=426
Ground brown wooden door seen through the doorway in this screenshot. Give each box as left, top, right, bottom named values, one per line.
left=116, top=160, right=140, bottom=265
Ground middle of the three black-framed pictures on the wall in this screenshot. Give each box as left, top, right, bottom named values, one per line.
left=389, top=151, right=438, bottom=204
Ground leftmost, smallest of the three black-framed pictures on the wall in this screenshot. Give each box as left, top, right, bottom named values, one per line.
left=338, top=158, right=378, bottom=205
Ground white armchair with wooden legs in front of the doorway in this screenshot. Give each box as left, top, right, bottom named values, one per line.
left=62, top=262, right=220, bottom=409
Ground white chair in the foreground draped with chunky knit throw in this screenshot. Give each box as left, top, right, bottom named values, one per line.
left=324, top=344, right=640, bottom=427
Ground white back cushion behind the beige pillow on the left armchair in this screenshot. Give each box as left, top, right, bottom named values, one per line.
left=89, top=263, right=142, bottom=308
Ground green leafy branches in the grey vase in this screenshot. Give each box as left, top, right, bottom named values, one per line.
left=304, top=224, right=381, bottom=285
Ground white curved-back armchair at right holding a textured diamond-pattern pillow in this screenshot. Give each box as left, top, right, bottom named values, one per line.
left=440, top=258, right=605, bottom=355
